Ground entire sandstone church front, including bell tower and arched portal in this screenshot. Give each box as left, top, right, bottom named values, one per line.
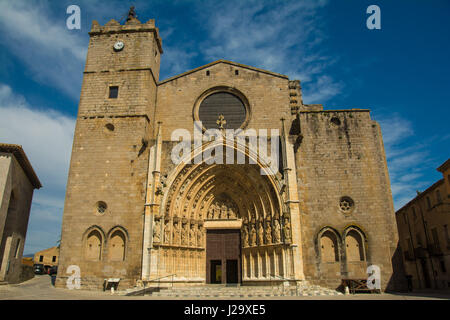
left=56, top=18, right=397, bottom=290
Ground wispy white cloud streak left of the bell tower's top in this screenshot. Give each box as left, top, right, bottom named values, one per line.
left=0, top=1, right=88, bottom=99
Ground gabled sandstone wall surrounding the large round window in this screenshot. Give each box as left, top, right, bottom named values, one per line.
left=156, top=62, right=291, bottom=140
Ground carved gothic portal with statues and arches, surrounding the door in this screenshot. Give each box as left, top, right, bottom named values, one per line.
left=153, top=142, right=293, bottom=282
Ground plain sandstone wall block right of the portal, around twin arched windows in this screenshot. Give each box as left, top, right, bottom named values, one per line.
left=296, top=110, right=397, bottom=289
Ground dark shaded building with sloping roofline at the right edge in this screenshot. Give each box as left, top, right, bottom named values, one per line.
left=395, top=159, right=450, bottom=290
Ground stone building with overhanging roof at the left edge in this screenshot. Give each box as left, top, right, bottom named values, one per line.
left=0, top=143, right=41, bottom=283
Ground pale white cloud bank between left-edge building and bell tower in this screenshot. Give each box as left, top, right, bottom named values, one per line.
left=0, top=84, right=75, bottom=253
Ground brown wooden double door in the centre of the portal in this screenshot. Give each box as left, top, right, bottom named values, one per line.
left=206, top=229, right=242, bottom=284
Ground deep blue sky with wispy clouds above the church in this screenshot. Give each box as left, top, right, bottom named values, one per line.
left=0, top=0, right=450, bottom=253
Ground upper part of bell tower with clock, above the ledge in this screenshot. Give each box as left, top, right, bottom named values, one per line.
left=79, top=17, right=163, bottom=120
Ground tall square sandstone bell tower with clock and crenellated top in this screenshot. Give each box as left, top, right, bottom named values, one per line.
left=57, top=11, right=163, bottom=288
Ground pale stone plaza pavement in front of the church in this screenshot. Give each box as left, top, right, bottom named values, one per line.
left=0, top=275, right=450, bottom=300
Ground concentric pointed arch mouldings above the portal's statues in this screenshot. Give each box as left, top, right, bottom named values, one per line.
left=160, top=142, right=285, bottom=219
